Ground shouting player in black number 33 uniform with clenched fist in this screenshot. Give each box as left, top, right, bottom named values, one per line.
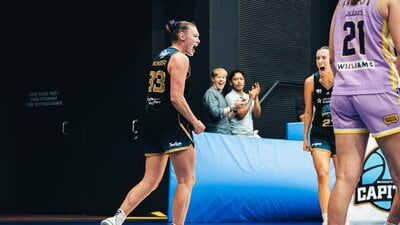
left=101, top=20, right=205, bottom=225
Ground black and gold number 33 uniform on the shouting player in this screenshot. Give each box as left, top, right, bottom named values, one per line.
left=143, top=48, right=193, bottom=156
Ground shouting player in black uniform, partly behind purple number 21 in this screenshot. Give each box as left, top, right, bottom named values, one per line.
left=303, top=46, right=337, bottom=225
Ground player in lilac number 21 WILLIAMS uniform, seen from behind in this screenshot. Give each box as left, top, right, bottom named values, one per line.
left=328, top=0, right=400, bottom=225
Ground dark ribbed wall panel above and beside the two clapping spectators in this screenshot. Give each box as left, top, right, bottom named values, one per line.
left=239, top=0, right=314, bottom=138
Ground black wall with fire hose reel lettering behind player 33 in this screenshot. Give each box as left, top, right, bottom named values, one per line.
left=0, top=2, right=155, bottom=215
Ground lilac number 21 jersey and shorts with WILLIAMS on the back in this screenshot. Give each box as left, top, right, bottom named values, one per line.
left=331, top=0, right=400, bottom=138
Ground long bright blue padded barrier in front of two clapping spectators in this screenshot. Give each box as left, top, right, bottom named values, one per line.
left=168, top=133, right=332, bottom=223
